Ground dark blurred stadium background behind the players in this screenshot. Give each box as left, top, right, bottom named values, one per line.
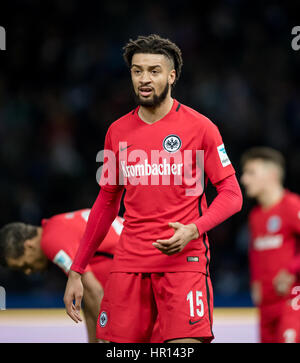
left=0, top=0, right=300, bottom=308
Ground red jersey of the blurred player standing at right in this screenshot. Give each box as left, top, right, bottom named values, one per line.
left=249, top=190, right=300, bottom=304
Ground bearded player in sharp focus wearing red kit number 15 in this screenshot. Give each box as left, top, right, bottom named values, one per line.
left=64, top=34, right=242, bottom=343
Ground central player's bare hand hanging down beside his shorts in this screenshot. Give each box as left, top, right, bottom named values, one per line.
left=64, top=271, right=83, bottom=323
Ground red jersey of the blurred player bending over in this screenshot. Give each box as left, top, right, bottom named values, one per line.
left=41, top=209, right=123, bottom=274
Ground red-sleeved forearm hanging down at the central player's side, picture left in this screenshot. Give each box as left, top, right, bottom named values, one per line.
left=71, top=189, right=122, bottom=274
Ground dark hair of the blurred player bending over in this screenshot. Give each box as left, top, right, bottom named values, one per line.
left=0, top=222, right=38, bottom=267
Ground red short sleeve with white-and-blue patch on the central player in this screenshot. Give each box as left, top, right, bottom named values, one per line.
left=202, top=120, right=235, bottom=184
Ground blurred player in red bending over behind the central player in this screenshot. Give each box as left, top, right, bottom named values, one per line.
left=0, top=209, right=123, bottom=343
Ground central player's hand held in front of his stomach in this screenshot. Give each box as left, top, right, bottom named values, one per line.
left=153, top=222, right=199, bottom=256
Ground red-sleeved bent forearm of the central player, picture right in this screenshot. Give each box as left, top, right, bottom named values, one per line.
left=194, top=175, right=243, bottom=235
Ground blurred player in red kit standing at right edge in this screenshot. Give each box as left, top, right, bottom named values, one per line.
left=241, top=147, right=300, bottom=343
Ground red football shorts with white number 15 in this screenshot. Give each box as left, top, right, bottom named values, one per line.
left=97, top=272, right=214, bottom=343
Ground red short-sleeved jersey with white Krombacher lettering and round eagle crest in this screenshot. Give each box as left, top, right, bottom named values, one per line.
left=100, top=100, right=235, bottom=273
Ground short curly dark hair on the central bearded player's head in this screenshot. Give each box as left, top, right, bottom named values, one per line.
left=123, top=34, right=183, bottom=87
